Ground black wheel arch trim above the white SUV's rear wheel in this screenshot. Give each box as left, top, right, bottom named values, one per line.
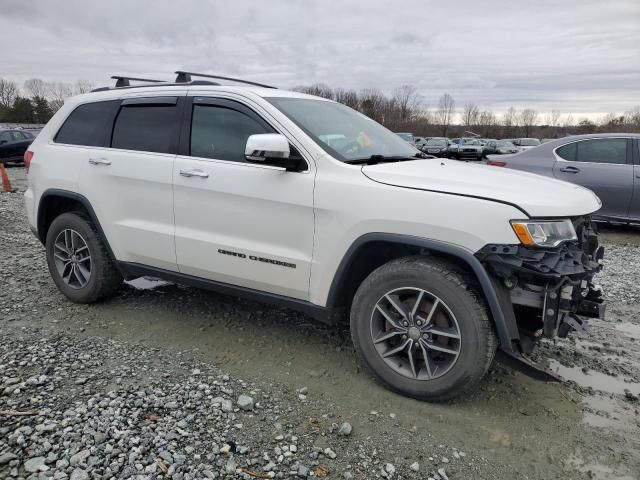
left=36, top=188, right=116, bottom=262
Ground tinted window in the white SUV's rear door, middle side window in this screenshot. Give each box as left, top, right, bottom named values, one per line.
left=111, top=104, right=178, bottom=153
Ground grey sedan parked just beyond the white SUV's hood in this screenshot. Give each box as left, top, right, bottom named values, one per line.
left=487, top=133, right=640, bottom=223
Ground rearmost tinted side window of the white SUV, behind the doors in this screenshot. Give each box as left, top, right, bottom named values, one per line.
left=54, top=101, right=117, bottom=147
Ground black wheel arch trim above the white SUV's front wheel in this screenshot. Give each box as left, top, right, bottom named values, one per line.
left=326, top=233, right=520, bottom=352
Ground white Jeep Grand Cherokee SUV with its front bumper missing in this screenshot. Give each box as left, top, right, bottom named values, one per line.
left=25, top=73, right=603, bottom=400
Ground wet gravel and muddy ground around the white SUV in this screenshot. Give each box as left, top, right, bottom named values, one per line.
left=0, top=168, right=640, bottom=480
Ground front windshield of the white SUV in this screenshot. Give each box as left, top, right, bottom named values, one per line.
left=266, top=97, right=420, bottom=162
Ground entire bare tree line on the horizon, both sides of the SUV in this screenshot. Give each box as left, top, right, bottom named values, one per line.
left=0, top=78, right=640, bottom=138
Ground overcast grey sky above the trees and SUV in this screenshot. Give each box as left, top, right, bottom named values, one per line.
left=0, top=0, right=640, bottom=117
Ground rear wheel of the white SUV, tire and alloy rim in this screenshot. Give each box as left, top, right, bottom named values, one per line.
left=45, top=212, right=122, bottom=303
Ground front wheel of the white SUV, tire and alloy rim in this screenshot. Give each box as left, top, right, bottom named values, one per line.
left=351, top=256, right=497, bottom=402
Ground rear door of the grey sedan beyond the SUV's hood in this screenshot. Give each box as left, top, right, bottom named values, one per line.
left=553, top=137, right=634, bottom=219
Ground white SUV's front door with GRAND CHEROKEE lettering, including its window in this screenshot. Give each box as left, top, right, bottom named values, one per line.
left=173, top=97, right=314, bottom=300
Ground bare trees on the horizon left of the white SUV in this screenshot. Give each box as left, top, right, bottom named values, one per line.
left=0, top=78, right=93, bottom=123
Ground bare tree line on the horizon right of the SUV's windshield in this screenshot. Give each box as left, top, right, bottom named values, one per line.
left=294, top=83, right=640, bottom=138
